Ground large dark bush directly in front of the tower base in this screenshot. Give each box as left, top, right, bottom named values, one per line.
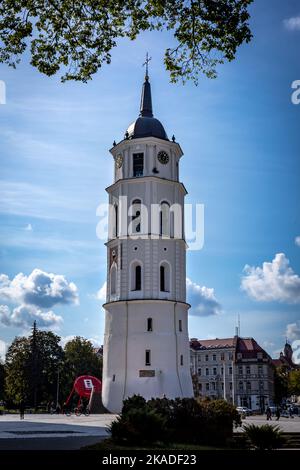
left=110, top=395, right=241, bottom=445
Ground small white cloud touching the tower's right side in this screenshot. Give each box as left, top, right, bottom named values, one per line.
left=186, top=278, right=221, bottom=316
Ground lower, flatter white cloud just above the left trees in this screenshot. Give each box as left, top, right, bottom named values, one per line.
left=0, top=305, right=63, bottom=328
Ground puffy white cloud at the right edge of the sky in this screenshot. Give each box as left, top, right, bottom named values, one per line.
left=241, top=253, right=300, bottom=304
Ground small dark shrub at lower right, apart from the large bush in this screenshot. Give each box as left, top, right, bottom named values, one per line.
left=243, top=424, right=284, bottom=450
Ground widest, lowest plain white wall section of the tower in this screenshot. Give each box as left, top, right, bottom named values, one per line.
left=102, top=300, right=193, bottom=412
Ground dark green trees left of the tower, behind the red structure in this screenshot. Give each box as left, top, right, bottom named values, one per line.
left=0, top=326, right=102, bottom=408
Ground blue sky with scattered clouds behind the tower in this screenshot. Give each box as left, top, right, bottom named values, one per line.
left=0, top=0, right=300, bottom=362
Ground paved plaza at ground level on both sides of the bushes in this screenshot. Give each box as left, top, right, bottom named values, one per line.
left=0, top=414, right=300, bottom=450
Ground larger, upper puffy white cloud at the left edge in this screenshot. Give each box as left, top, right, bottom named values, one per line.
left=0, top=269, right=78, bottom=308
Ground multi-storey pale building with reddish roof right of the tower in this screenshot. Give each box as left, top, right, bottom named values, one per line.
left=190, top=336, right=274, bottom=411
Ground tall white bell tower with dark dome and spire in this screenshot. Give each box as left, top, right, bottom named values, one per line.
left=102, top=60, right=193, bottom=413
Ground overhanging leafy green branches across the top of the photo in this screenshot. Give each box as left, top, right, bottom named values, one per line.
left=0, top=0, right=253, bottom=83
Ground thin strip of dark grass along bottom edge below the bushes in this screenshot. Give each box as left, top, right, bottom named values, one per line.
left=81, top=439, right=228, bottom=451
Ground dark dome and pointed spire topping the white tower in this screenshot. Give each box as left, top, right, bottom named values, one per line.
left=125, top=73, right=169, bottom=140
